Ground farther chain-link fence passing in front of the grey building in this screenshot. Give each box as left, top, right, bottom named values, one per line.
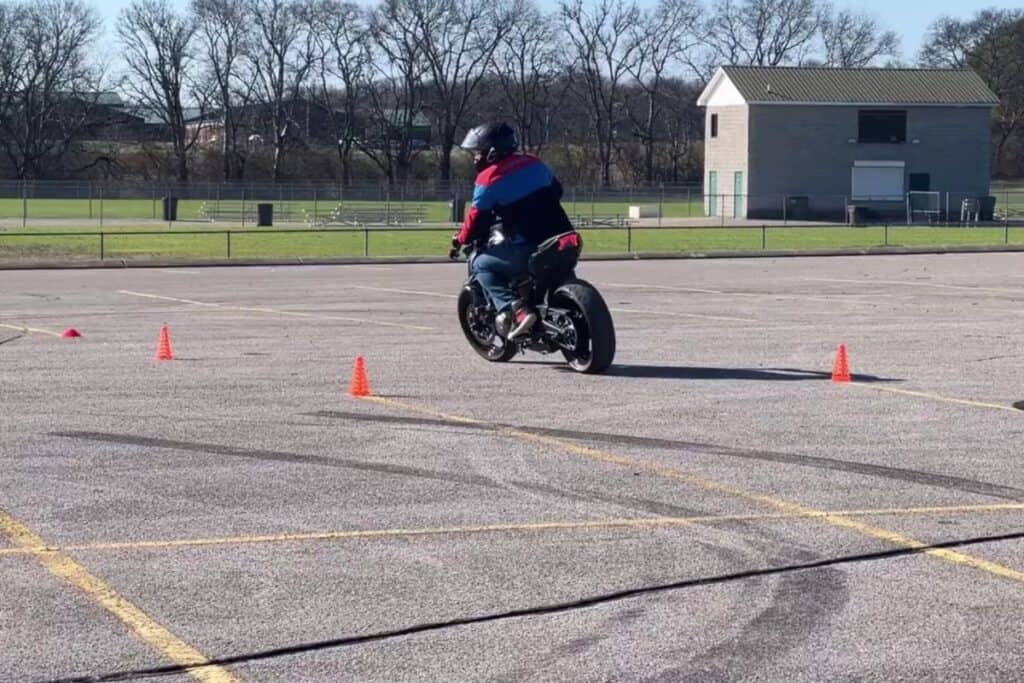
left=0, top=181, right=1024, bottom=230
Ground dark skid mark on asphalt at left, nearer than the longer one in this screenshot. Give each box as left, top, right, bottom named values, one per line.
left=49, top=431, right=502, bottom=488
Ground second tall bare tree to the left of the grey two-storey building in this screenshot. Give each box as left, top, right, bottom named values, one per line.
left=559, top=0, right=640, bottom=186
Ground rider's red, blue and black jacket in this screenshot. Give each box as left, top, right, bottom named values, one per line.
left=459, top=155, right=572, bottom=245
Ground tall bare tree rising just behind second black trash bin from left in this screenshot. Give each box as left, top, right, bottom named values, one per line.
left=247, top=0, right=314, bottom=182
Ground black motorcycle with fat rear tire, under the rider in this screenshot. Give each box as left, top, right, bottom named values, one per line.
left=450, top=225, right=615, bottom=375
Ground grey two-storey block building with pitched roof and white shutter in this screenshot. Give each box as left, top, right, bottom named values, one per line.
left=697, top=67, right=998, bottom=219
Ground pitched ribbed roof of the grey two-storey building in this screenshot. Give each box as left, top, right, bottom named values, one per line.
left=699, top=67, right=999, bottom=106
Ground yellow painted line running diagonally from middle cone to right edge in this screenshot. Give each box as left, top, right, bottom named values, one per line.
left=365, top=396, right=1024, bottom=583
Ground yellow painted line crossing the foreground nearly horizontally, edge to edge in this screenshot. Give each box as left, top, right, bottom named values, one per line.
left=0, top=503, right=1024, bottom=557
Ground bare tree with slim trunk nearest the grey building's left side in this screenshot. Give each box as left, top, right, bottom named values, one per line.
left=628, top=0, right=702, bottom=182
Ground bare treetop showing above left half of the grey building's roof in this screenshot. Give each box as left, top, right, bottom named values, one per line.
left=710, top=0, right=818, bottom=67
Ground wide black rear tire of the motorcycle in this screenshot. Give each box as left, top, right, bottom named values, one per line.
left=551, top=280, right=615, bottom=375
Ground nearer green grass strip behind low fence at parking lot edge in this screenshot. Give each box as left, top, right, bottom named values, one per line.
left=0, top=224, right=1024, bottom=261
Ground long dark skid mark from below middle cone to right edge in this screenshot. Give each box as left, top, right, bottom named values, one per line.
left=304, top=411, right=1024, bottom=501
